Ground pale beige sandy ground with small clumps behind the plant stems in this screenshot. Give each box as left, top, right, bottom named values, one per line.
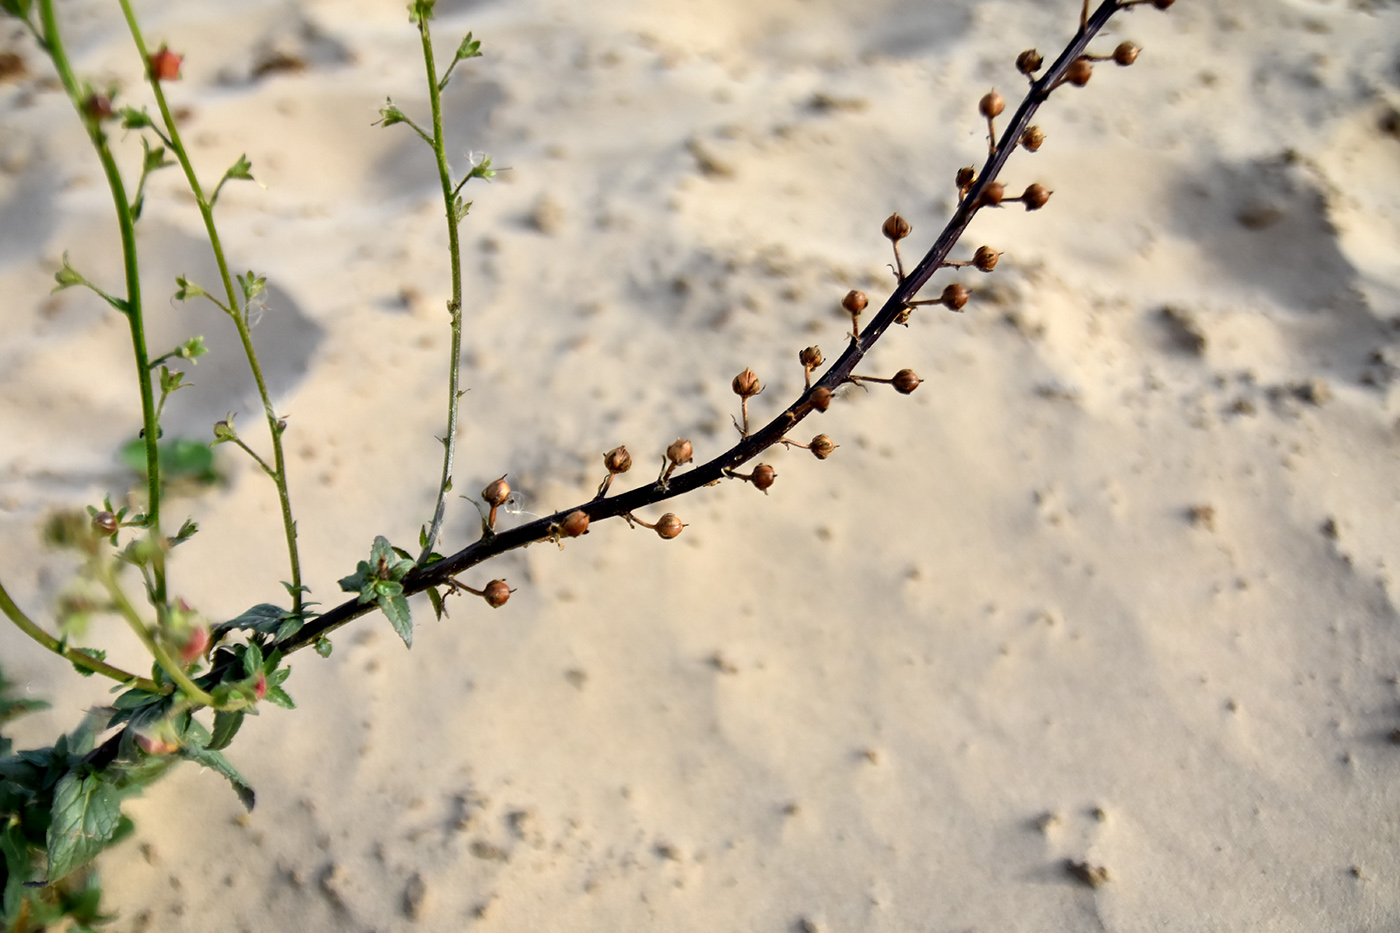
left=0, top=0, right=1400, bottom=933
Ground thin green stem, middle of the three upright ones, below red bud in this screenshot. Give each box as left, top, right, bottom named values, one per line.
left=119, top=0, right=302, bottom=614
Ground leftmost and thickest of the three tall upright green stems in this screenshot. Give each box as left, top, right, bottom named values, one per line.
left=39, top=0, right=165, bottom=611
